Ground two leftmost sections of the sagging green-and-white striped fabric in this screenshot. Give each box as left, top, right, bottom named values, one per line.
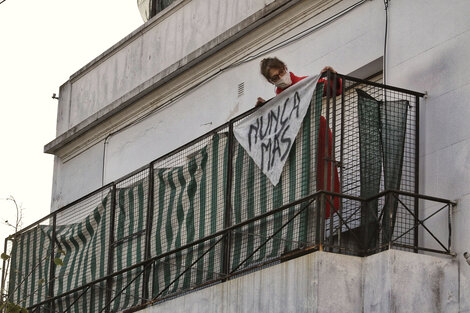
left=9, top=195, right=109, bottom=312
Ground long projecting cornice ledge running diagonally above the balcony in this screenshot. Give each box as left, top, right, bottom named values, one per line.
left=44, top=0, right=341, bottom=158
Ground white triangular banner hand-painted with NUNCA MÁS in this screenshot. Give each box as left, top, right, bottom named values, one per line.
left=234, top=75, right=320, bottom=186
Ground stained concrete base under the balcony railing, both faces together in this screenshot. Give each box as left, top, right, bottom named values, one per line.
left=140, top=250, right=459, bottom=313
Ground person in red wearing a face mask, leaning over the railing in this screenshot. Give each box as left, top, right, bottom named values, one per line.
left=256, top=57, right=343, bottom=218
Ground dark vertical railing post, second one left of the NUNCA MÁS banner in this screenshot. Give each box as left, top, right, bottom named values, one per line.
left=142, top=162, right=155, bottom=304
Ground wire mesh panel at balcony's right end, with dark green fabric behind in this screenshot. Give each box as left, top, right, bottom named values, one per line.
left=323, top=77, right=417, bottom=251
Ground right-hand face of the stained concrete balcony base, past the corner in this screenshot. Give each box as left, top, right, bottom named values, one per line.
left=363, top=250, right=459, bottom=313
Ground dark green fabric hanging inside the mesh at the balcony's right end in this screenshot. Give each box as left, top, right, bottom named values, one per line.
left=356, top=89, right=409, bottom=248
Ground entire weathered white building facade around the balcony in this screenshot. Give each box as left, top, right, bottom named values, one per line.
left=7, top=0, right=470, bottom=312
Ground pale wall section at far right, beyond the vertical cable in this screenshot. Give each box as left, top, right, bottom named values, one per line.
left=389, top=0, right=470, bottom=312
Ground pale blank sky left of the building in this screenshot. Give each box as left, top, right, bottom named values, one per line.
left=0, top=0, right=143, bottom=256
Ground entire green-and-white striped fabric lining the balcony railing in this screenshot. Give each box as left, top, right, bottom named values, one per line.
left=9, top=85, right=323, bottom=313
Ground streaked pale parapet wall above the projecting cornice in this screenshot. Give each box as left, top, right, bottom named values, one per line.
left=57, top=0, right=274, bottom=135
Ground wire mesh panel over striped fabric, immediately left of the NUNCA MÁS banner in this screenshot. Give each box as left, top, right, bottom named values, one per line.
left=150, top=129, right=228, bottom=297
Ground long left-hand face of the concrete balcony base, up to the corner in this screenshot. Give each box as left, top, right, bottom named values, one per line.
left=141, top=252, right=362, bottom=313
